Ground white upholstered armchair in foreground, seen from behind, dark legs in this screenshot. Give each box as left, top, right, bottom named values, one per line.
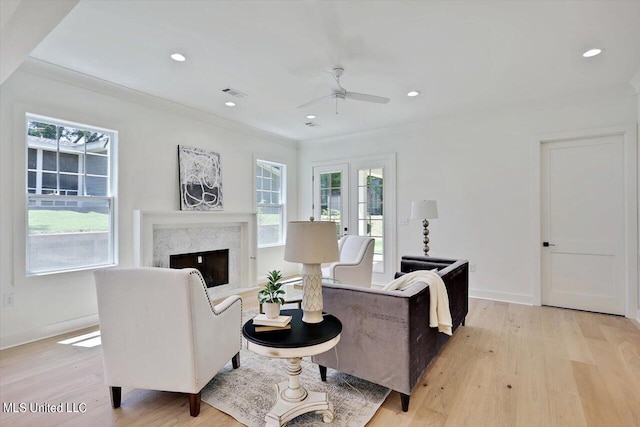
left=95, top=268, right=242, bottom=417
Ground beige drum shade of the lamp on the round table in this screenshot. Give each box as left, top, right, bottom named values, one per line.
left=284, top=221, right=340, bottom=264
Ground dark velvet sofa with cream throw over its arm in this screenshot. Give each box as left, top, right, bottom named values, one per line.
left=312, top=256, right=469, bottom=412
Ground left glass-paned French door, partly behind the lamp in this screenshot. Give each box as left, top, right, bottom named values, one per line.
left=313, top=164, right=350, bottom=238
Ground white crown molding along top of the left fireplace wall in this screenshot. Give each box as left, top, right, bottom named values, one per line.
left=18, top=57, right=298, bottom=148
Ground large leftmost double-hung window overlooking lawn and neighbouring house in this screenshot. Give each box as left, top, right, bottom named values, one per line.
left=26, top=115, right=117, bottom=274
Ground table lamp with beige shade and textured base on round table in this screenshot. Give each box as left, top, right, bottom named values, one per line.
left=284, top=218, right=340, bottom=323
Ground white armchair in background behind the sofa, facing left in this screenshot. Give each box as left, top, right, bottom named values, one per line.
left=322, top=235, right=375, bottom=287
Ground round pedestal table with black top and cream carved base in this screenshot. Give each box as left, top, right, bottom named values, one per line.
left=242, top=310, right=342, bottom=427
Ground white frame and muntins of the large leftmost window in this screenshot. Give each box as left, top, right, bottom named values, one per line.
left=23, top=112, right=119, bottom=277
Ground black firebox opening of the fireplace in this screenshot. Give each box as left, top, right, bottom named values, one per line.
left=169, top=249, right=229, bottom=288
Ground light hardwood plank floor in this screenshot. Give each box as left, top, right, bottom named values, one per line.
left=0, top=295, right=640, bottom=427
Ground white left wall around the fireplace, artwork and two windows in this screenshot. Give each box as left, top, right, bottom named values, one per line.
left=0, top=61, right=298, bottom=347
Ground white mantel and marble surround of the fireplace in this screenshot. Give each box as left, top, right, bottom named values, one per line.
left=133, top=210, right=258, bottom=296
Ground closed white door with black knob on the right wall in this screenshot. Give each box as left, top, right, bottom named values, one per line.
left=541, top=135, right=625, bottom=314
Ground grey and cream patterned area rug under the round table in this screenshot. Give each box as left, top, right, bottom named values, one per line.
left=202, top=310, right=390, bottom=427
